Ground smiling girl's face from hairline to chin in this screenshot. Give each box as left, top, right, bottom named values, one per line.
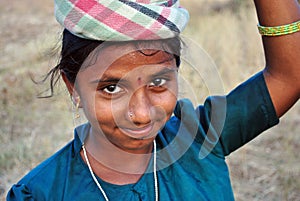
left=66, top=45, right=178, bottom=153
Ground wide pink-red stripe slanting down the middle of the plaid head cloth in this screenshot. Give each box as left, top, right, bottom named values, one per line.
left=75, top=0, right=158, bottom=39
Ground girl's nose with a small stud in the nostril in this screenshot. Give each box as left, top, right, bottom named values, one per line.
left=129, top=87, right=153, bottom=125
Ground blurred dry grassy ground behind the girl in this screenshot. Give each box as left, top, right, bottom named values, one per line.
left=0, top=0, right=300, bottom=201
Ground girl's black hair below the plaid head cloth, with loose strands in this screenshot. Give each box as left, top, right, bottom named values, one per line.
left=43, top=29, right=181, bottom=97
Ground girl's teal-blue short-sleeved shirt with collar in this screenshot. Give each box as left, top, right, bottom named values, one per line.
left=7, top=73, right=279, bottom=201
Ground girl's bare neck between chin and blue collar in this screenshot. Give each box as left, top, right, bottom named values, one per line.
left=81, top=128, right=153, bottom=185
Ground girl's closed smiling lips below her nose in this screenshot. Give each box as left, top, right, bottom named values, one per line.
left=119, top=124, right=154, bottom=139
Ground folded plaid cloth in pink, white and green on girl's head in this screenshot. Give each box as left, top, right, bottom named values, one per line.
left=55, top=0, right=189, bottom=41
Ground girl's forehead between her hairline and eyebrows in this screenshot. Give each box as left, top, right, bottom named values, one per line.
left=80, top=44, right=175, bottom=77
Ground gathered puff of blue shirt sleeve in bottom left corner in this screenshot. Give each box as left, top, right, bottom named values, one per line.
left=6, top=184, right=34, bottom=201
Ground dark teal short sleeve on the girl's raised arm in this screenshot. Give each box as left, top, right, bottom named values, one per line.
left=204, top=72, right=279, bottom=156
